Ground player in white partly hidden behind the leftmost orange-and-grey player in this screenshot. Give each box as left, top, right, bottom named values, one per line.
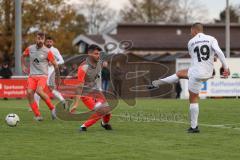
left=34, top=36, right=65, bottom=106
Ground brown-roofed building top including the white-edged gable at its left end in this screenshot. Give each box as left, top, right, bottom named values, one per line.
left=73, top=24, right=240, bottom=56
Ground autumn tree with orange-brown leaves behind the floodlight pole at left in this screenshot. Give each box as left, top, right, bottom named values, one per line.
left=0, top=0, right=86, bottom=61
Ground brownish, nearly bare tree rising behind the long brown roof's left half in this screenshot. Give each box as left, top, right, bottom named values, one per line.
left=120, top=0, right=178, bottom=23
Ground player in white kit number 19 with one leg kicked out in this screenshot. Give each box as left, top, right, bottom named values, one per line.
left=150, top=23, right=229, bottom=133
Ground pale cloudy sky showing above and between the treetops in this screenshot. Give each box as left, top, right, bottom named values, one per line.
left=70, top=0, right=240, bottom=20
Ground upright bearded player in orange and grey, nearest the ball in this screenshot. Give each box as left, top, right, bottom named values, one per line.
left=21, top=32, right=60, bottom=121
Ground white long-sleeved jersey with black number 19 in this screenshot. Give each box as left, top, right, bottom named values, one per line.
left=188, top=33, right=228, bottom=79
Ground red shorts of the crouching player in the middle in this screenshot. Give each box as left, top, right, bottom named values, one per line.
left=81, top=96, right=106, bottom=110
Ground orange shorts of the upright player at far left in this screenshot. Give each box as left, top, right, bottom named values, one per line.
left=27, top=76, right=47, bottom=91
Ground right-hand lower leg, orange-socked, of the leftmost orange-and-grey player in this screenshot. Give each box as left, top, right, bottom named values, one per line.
left=37, top=87, right=57, bottom=120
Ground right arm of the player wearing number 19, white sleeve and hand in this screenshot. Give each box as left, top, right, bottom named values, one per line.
left=212, top=39, right=230, bottom=78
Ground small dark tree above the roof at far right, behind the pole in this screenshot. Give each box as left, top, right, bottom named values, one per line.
left=215, top=6, right=240, bottom=23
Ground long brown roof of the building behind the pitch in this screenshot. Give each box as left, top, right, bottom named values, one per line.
left=74, top=23, right=240, bottom=51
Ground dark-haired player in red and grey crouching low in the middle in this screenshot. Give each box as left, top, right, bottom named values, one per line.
left=78, top=44, right=112, bottom=132
